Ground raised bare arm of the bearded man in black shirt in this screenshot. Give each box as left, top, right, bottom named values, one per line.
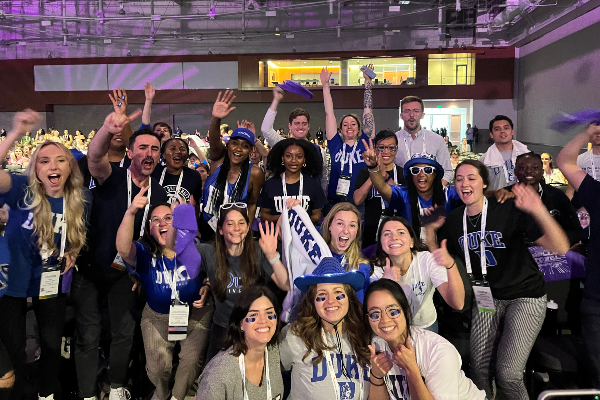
left=87, top=110, right=142, bottom=184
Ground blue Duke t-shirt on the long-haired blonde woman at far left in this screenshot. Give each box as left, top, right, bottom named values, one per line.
left=0, top=174, right=91, bottom=297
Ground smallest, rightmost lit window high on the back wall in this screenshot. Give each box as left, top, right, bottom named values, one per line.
left=427, top=53, right=475, bottom=85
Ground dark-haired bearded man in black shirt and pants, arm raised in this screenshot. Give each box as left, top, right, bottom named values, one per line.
left=71, top=110, right=167, bottom=400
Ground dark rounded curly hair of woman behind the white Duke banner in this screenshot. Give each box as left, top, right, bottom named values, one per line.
left=267, top=138, right=323, bottom=178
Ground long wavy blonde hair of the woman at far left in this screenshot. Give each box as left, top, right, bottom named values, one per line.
left=25, top=140, right=86, bottom=257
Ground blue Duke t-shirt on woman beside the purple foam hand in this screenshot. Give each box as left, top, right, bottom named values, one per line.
left=127, top=242, right=202, bottom=314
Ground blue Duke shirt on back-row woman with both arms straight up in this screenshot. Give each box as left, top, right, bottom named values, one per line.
left=327, top=132, right=369, bottom=199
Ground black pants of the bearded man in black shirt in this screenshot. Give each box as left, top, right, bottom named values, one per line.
left=71, top=272, right=136, bottom=397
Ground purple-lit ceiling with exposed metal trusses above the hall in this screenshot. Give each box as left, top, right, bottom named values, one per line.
left=0, top=0, right=600, bottom=59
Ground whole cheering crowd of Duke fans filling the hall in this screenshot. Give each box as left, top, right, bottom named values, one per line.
left=0, top=65, right=600, bottom=400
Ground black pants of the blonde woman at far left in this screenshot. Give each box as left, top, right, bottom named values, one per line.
left=0, top=294, right=67, bottom=397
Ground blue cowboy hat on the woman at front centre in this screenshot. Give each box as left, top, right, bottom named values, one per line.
left=294, top=257, right=366, bottom=293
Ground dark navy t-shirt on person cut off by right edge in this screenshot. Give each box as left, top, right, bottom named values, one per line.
left=577, top=175, right=600, bottom=299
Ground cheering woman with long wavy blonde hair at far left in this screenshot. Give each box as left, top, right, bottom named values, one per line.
left=0, top=110, right=91, bottom=398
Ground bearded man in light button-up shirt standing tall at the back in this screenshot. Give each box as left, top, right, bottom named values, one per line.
left=395, top=96, right=453, bottom=185
